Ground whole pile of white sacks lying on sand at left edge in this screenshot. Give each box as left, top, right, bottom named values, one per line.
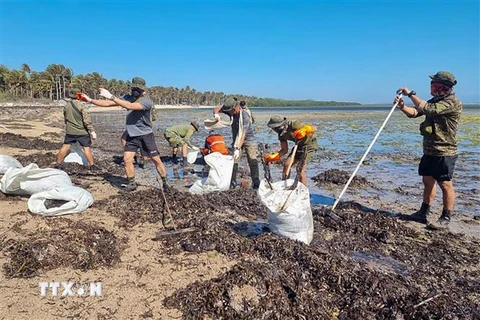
left=0, top=155, right=93, bottom=216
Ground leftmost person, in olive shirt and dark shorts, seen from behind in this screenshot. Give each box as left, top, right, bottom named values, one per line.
left=55, top=89, right=100, bottom=170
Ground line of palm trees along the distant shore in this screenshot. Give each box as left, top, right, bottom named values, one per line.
left=0, top=63, right=359, bottom=107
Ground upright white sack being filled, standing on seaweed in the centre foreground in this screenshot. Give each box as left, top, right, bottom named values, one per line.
left=258, top=179, right=313, bottom=244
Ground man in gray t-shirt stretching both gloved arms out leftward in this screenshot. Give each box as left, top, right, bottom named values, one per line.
left=82, top=77, right=168, bottom=192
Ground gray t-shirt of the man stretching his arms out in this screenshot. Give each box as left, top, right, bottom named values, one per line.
left=123, top=94, right=153, bottom=137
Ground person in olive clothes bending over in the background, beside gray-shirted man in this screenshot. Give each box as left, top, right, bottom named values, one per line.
left=164, top=121, right=199, bottom=168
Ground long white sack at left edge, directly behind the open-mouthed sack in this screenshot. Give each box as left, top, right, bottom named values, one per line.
left=0, top=163, right=72, bottom=195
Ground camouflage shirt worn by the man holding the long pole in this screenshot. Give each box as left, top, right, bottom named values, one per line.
left=417, top=93, right=462, bottom=156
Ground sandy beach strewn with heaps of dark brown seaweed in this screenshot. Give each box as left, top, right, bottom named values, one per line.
left=0, top=106, right=480, bottom=319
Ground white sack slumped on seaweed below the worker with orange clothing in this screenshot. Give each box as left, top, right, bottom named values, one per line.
left=188, top=152, right=233, bottom=194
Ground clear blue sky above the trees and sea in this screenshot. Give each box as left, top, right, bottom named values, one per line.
left=0, top=0, right=480, bottom=103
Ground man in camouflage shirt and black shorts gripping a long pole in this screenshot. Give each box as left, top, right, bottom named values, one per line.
left=395, top=71, right=462, bottom=224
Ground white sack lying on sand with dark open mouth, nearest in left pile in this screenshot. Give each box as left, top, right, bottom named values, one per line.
left=28, top=186, right=93, bottom=217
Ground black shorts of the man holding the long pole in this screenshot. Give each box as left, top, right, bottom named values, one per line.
left=418, top=155, right=458, bottom=182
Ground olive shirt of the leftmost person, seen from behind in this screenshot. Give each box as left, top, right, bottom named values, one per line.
left=63, top=100, right=95, bottom=136
